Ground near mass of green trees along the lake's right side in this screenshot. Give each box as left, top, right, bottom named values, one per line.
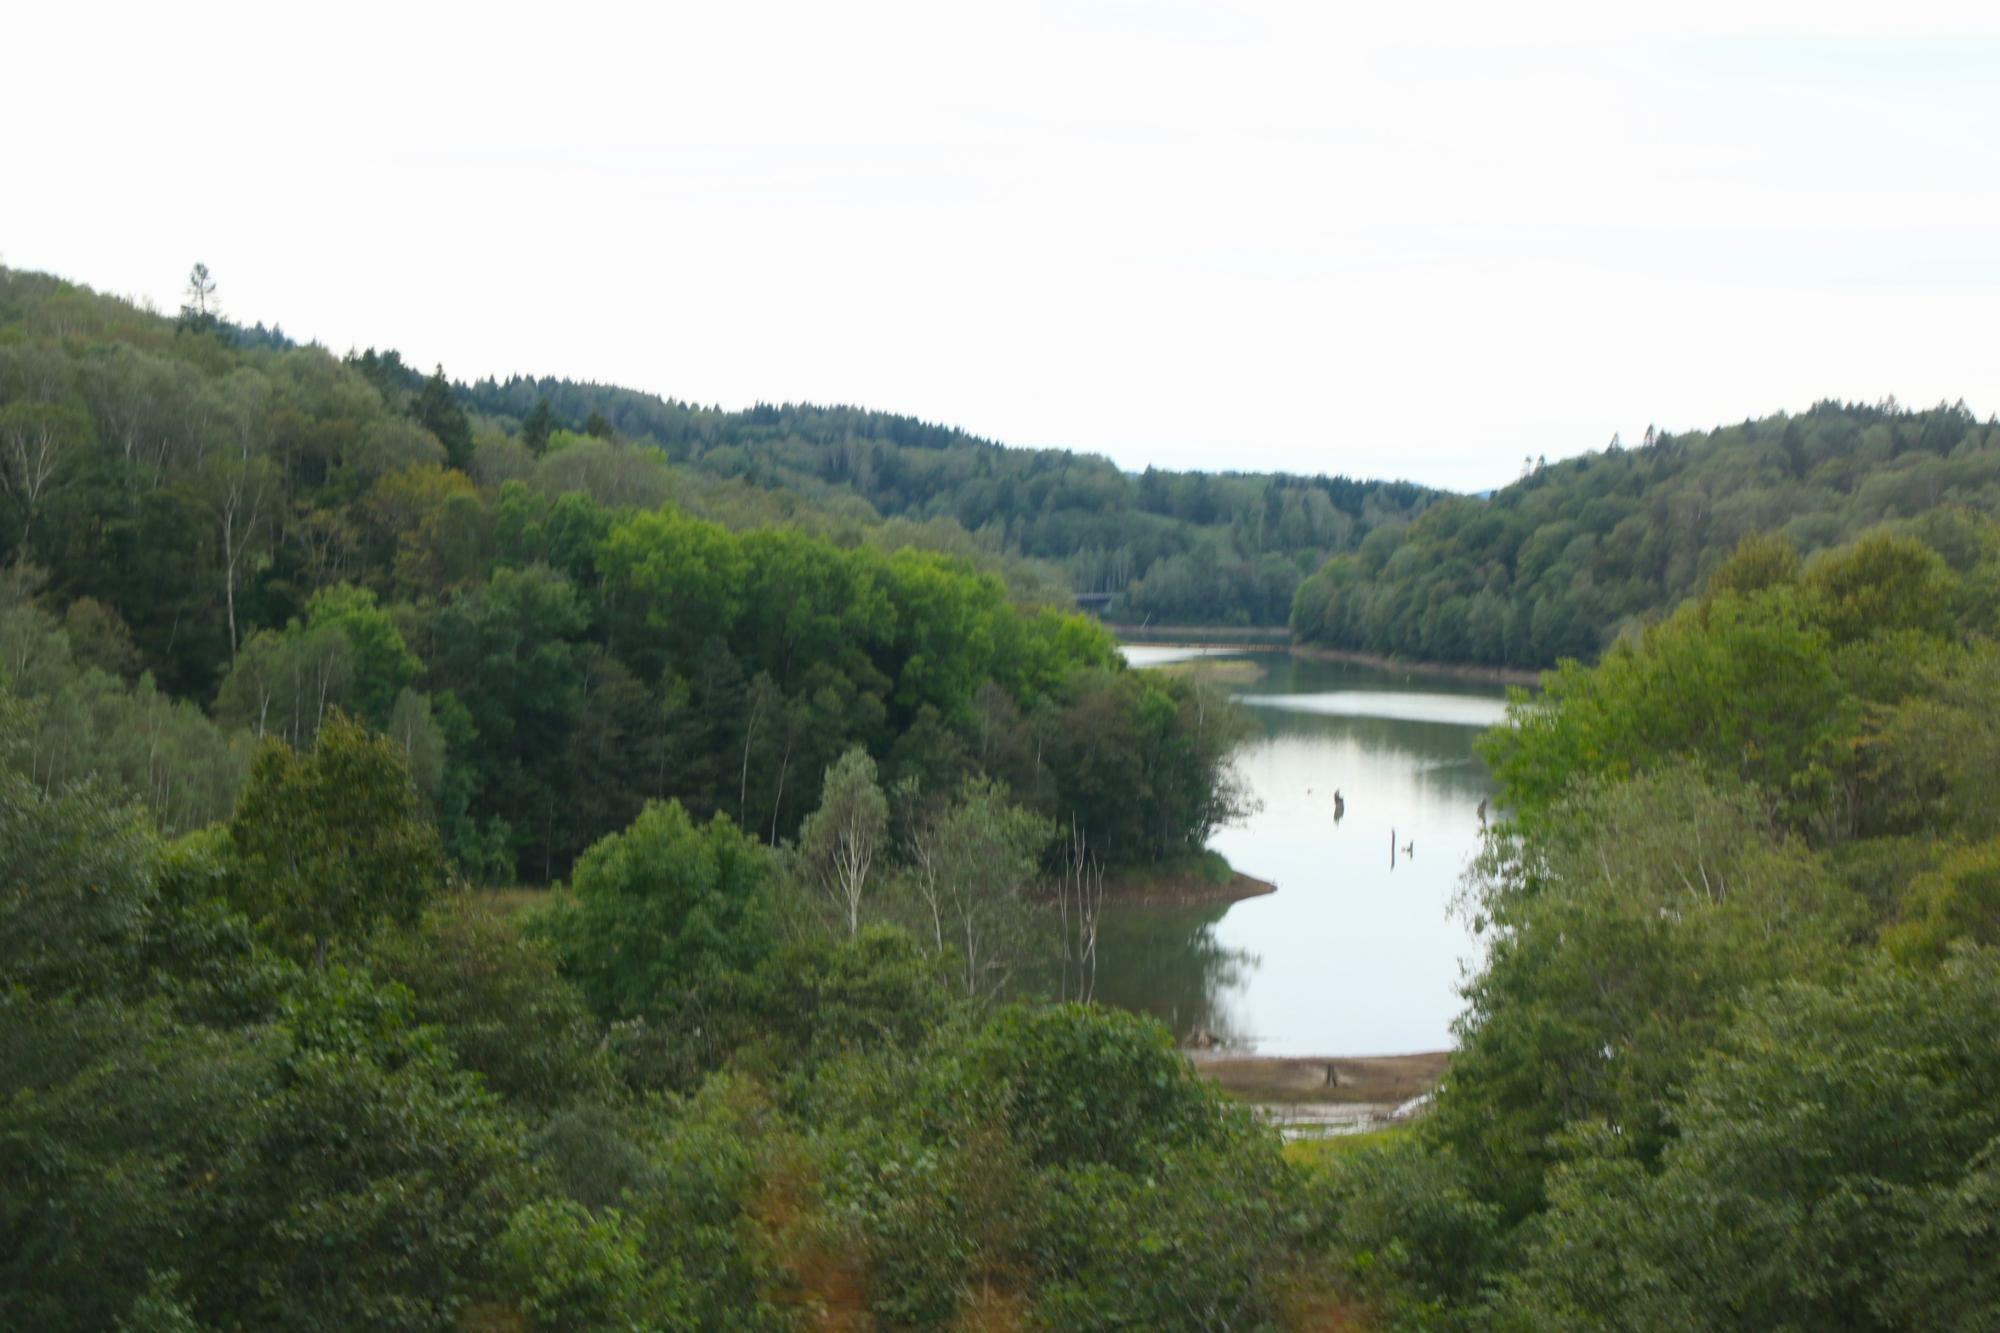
left=1328, top=508, right=2000, bottom=1329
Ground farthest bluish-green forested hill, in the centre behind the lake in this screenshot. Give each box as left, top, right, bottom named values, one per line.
left=462, top=362, right=1440, bottom=624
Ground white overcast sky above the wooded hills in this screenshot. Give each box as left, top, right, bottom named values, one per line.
left=11, top=0, right=2000, bottom=488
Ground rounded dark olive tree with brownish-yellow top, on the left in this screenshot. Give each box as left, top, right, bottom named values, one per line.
left=230, top=715, right=444, bottom=963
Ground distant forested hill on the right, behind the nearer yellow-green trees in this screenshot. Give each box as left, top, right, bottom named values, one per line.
left=1292, top=400, right=2000, bottom=667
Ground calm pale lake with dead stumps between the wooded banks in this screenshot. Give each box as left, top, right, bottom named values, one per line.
left=1098, top=646, right=1504, bottom=1055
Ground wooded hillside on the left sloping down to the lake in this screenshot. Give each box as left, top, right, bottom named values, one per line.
left=0, top=268, right=1232, bottom=881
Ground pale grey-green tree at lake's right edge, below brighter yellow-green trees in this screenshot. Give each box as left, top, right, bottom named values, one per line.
left=1428, top=771, right=1862, bottom=1221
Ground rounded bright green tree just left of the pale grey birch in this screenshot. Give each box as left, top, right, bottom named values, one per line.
left=536, top=803, right=770, bottom=1019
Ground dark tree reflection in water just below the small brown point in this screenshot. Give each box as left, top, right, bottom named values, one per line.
left=1098, top=905, right=1256, bottom=1043
